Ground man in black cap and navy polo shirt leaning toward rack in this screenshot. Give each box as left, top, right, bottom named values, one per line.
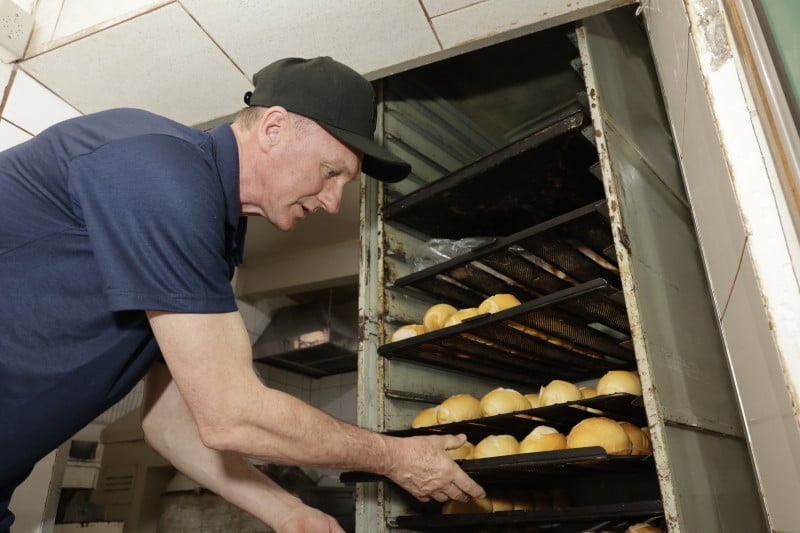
left=0, top=58, right=484, bottom=533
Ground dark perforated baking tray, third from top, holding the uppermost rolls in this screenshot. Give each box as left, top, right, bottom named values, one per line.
left=378, top=279, right=635, bottom=388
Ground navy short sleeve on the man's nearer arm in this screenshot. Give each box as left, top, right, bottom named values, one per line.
left=69, top=134, right=236, bottom=313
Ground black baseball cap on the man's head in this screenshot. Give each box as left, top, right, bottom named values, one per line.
left=244, top=57, right=411, bottom=183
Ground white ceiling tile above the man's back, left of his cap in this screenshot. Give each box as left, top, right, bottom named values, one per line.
left=22, top=4, right=250, bottom=124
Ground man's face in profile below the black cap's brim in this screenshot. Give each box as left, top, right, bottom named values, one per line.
left=243, top=115, right=361, bottom=231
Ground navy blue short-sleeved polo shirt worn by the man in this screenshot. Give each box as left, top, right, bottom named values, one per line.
left=0, top=109, right=244, bottom=532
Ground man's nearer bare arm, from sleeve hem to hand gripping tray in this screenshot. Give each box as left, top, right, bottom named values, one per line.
left=148, top=312, right=484, bottom=501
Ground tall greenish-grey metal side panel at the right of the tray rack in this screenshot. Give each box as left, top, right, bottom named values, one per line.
left=579, top=8, right=766, bottom=533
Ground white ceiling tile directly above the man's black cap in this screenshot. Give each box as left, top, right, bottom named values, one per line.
left=181, top=0, right=439, bottom=76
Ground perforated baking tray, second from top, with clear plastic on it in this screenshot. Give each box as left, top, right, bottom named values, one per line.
left=392, top=201, right=621, bottom=307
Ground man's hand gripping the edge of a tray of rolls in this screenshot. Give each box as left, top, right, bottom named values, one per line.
left=386, top=435, right=486, bottom=502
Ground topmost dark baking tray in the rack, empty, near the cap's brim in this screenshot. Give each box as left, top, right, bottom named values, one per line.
left=383, top=111, right=604, bottom=239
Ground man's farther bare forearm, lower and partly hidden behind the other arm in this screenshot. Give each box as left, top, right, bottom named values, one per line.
left=142, top=364, right=344, bottom=533
